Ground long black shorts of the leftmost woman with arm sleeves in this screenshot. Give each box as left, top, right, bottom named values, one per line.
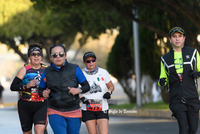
left=18, top=99, right=47, bottom=132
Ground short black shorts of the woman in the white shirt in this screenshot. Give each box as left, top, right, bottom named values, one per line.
left=82, top=110, right=109, bottom=122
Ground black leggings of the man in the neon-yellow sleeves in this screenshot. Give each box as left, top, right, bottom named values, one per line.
left=174, top=107, right=199, bottom=134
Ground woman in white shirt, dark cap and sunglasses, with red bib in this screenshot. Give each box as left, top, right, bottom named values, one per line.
left=80, top=52, right=114, bottom=134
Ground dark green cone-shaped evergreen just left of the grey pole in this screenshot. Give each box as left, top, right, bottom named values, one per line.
left=107, top=22, right=134, bottom=80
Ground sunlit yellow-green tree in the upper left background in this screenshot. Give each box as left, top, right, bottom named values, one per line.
left=0, top=0, right=87, bottom=62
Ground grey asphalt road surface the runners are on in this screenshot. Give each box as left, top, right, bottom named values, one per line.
left=0, top=106, right=200, bottom=134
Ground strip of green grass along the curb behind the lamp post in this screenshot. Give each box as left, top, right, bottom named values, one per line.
left=109, top=101, right=169, bottom=110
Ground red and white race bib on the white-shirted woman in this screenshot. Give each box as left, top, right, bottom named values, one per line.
left=87, top=99, right=102, bottom=111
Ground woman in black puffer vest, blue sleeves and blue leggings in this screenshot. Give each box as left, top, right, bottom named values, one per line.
left=39, top=44, right=90, bottom=134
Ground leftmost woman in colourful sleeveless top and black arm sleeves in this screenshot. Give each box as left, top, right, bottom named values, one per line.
left=10, top=43, right=47, bottom=134
